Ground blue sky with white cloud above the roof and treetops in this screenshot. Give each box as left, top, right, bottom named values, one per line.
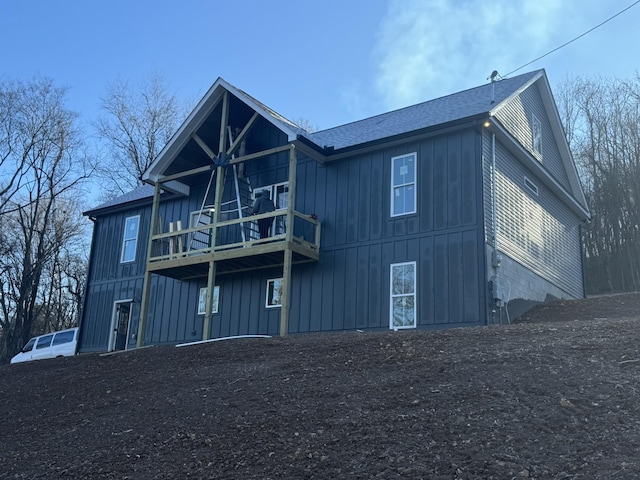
left=0, top=0, right=640, bottom=129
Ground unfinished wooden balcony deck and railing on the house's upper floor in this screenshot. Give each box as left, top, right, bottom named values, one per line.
left=147, top=209, right=320, bottom=280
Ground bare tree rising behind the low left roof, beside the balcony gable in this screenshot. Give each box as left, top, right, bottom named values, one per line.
left=96, top=74, right=184, bottom=197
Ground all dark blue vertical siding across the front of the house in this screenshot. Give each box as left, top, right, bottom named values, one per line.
left=83, top=128, right=485, bottom=350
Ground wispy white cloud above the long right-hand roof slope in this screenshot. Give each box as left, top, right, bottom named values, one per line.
left=374, top=0, right=581, bottom=109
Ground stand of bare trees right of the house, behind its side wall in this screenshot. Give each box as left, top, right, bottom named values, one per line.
left=558, top=75, right=640, bottom=294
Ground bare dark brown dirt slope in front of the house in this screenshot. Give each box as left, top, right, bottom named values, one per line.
left=0, top=294, right=640, bottom=480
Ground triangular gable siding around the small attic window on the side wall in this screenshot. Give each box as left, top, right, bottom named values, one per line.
left=496, top=83, right=571, bottom=191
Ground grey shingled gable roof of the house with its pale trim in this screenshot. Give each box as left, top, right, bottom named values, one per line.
left=91, top=70, right=588, bottom=217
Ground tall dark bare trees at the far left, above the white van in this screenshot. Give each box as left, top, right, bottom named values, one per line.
left=0, top=79, right=91, bottom=362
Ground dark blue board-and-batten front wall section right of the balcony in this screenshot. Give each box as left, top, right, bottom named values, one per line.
left=290, top=129, right=485, bottom=332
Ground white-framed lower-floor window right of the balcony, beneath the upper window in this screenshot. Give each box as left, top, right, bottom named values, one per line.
left=389, top=262, right=418, bottom=330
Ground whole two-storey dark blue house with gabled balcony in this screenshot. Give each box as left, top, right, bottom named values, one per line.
left=79, top=70, right=589, bottom=352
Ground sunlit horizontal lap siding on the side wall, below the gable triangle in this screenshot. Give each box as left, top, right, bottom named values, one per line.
left=484, top=129, right=583, bottom=298
